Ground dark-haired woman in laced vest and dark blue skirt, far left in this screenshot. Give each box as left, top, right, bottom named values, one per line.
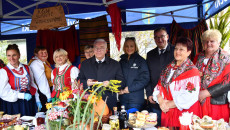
left=0, top=44, right=41, bottom=116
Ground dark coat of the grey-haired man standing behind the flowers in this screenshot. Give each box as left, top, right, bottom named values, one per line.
left=78, top=56, right=124, bottom=110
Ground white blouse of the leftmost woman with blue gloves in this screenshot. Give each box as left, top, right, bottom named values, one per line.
left=0, top=63, right=40, bottom=102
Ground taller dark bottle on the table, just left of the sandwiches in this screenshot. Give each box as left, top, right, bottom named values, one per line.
left=119, top=105, right=129, bottom=130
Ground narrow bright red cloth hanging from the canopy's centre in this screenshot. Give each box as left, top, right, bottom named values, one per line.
left=106, top=0, right=122, bottom=51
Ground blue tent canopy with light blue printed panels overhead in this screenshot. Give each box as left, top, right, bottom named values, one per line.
left=0, top=0, right=230, bottom=35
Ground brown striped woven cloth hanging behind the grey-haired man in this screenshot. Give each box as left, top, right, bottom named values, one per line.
left=79, top=15, right=109, bottom=61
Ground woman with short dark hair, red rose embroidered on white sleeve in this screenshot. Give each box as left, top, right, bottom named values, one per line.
left=153, top=37, right=202, bottom=127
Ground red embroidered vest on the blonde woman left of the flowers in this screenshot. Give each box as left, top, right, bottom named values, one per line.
left=53, top=65, right=73, bottom=91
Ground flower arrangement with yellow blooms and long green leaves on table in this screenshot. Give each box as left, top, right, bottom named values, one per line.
left=46, top=80, right=121, bottom=130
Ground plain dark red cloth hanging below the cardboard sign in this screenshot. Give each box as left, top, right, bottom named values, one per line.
left=36, top=25, right=79, bottom=64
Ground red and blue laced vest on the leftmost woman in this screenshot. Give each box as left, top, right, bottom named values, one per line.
left=3, top=65, right=36, bottom=95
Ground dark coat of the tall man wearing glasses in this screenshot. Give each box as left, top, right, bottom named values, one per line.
left=146, top=44, right=175, bottom=97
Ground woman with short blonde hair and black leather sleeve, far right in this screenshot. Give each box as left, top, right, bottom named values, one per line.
left=194, top=30, right=230, bottom=122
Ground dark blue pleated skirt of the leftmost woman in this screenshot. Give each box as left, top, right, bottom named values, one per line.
left=0, top=96, right=37, bottom=116
